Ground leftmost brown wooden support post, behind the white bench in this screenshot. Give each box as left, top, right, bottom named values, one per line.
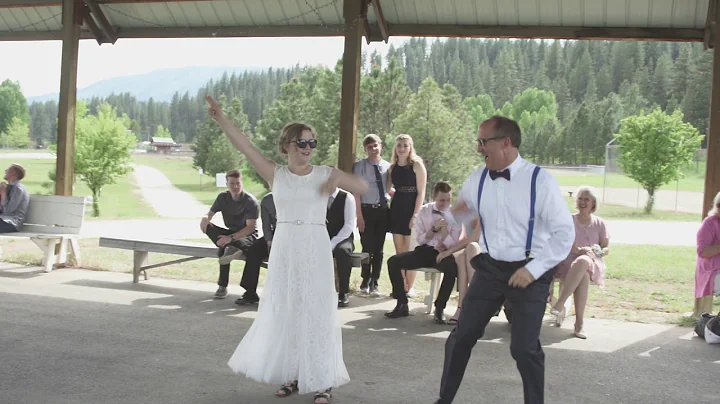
left=55, top=0, right=83, bottom=196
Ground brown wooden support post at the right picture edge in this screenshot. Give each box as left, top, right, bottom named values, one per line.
left=702, top=3, right=720, bottom=217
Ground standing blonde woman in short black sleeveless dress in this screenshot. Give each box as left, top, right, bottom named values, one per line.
left=388, top=134, right=427, bottom=296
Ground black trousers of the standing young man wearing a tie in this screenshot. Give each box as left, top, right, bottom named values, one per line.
left=360, top=204, right=388, bottom=287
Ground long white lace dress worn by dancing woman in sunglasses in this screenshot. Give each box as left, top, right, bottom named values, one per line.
left=228, top=165, right=350, bottom=394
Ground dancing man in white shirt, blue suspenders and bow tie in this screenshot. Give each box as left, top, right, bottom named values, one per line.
left=436, top=116, right=575, bottom=404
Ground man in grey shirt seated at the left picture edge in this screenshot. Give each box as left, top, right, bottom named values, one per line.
left=0, top=164, right=30, bottom=233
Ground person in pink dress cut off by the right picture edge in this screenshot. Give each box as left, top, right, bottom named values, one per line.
left=694, top=192, right=720, bottom=316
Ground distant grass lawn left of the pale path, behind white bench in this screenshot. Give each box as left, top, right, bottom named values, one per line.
left=0, top=155, right=156, bottom=219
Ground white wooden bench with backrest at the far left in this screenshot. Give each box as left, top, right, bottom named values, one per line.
left=0, top=194, right=85, bottom=272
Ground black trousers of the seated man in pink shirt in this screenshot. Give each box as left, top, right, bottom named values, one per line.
left=388, top=244, right=458, bottom=310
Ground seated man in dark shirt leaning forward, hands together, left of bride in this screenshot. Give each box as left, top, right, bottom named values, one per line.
left=200, top=170, right=259, bottom=299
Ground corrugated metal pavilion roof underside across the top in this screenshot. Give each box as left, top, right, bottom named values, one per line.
left=0, top=0, right=709, bottom=40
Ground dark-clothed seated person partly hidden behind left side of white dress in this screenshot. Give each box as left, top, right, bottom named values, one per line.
left=235, top=193, right=277, bottom=306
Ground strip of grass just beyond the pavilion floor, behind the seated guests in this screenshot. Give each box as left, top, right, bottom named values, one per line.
left=0, top=239, right=720, bottom=323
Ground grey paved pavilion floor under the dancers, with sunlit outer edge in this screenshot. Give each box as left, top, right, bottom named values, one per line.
left=0, top=263, right=720, bottom=404
